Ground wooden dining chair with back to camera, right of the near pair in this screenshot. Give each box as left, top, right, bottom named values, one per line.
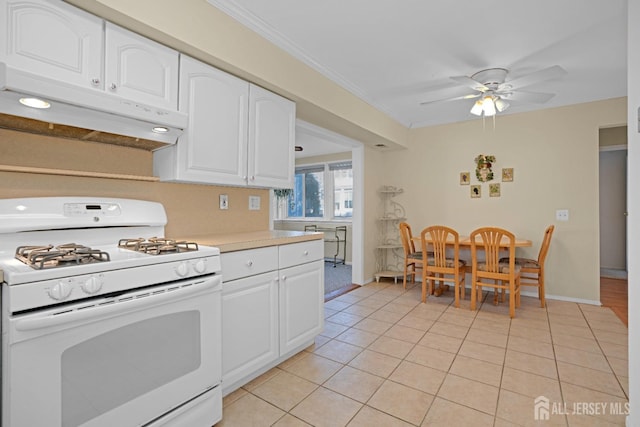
left=469, top=227, right=521, bottom=318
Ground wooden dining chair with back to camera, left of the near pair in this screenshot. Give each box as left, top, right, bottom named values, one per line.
left=420, top=225, right=466, bottom=307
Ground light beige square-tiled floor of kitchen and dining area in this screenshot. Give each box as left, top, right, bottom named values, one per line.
left=218, top=282, right=629, bottom=427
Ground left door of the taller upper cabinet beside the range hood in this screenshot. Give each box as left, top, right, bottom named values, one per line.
left=176, top=56, right=249, bottom=186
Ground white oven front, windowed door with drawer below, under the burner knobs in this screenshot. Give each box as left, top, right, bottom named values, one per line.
left=2, top=275, right=221, bottom=427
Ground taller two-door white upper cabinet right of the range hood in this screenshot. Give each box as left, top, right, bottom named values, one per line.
left=154, top=55, right=295, bottom=188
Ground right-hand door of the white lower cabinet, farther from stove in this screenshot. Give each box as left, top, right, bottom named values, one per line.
left=279, top=261, right=324, bottom=355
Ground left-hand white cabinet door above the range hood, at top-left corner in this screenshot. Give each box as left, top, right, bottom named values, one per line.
left=0, top=0, right=103, bottom=89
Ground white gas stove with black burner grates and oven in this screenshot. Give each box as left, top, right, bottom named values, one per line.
left=0, top=197, right=222, bottom=426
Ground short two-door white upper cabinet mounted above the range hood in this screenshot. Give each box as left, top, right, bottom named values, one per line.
left=0, top=0, right=179, bottom=111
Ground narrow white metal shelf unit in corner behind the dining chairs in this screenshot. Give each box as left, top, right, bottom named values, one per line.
left=375, top=186, right=406, bottom=283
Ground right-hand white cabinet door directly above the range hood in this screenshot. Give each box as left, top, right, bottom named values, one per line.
left=105, top=22, right=179, bottom=111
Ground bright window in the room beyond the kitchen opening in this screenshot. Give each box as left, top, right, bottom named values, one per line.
left=287, top=161, right=353, bottom=220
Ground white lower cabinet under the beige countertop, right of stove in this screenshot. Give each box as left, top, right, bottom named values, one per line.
left=221, top=240, right=324, bottom=395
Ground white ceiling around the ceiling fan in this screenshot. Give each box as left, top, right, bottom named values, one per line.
left=209, top=0, right=627, bottom=154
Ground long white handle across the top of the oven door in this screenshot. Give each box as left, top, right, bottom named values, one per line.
left=15, top=275, right=222, bottom=331
